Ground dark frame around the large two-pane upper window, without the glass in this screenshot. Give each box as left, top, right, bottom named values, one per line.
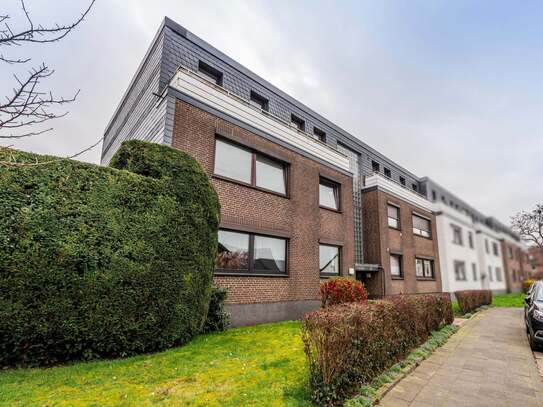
left=213, top=135, right=290, bottom=198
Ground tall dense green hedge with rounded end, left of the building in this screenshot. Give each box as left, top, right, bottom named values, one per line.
left=0, top=141, right=220, bottom=366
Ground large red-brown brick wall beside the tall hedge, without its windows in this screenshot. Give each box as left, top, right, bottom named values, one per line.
left=172, top=100, right=354, bottom=304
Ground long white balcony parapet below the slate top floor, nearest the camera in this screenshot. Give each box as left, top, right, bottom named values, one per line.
left=170, top=67, right=352, bottom=174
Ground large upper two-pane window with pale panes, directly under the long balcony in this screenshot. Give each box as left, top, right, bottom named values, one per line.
left=215, top=139, right=287, bottom=195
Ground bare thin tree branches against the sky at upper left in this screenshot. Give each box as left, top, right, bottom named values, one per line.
left=0, top=0, right=98, bottom=162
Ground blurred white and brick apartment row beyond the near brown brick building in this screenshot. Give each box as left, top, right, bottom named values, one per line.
left=421, top=178, right=529, bottom=293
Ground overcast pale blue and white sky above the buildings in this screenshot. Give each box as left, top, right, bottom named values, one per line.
left=0, top=0, right=543, bottom=222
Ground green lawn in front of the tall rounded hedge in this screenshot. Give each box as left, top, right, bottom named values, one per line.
left=0, top=321, right=311, bottom=406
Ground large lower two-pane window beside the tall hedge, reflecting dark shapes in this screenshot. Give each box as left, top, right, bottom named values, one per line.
left=215, top=229, right=287, bottom=274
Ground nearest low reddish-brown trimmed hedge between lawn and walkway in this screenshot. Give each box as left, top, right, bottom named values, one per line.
left=302, top=294, right=453, bottom=406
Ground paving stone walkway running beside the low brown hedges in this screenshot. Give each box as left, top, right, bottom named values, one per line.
left=379, top=308, right=543, bottom=407
